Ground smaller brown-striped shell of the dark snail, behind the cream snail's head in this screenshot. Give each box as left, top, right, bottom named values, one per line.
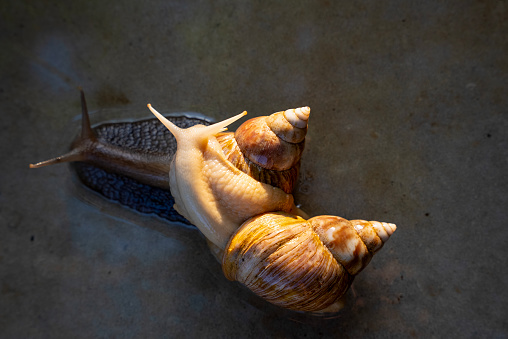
left=217, top=107, right=310, bottom=193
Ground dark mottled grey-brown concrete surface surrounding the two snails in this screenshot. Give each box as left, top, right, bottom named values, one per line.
left=0, top=0, right=508, bottom=338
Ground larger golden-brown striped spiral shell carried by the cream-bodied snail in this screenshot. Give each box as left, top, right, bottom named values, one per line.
left=222, top=212, right=396, bottom=312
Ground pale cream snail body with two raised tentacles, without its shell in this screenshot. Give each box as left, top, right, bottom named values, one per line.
left=149, top=106, right=302, bottom=249
